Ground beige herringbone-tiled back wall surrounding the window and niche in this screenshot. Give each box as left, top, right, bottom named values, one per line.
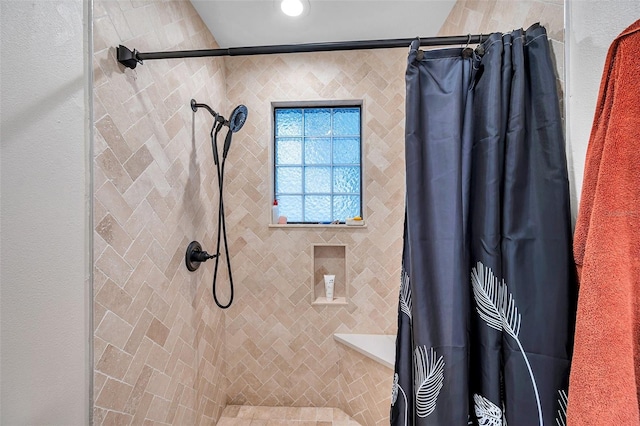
left=225, top=49, right=406, bottom=414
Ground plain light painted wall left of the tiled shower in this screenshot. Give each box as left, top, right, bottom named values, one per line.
left=0, top=0, right=90, bottom=425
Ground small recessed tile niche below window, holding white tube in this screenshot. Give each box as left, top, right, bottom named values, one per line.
left=312, top=244, right=348, bottom=305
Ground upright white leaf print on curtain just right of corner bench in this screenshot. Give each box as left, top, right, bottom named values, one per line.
left=413, top=346, right=444, bottom=417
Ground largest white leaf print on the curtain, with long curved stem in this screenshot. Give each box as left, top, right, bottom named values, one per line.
left=471, top=262, right=544, bottom=426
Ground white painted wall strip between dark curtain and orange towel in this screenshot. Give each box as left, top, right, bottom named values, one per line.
left=567, top=0, right=640, bottom=211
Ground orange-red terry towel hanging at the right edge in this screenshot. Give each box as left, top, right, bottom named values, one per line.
left=567, top=20, right=640, bottom=426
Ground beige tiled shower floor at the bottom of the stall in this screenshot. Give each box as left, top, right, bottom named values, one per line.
left=217, top=405, right=360, bottom=426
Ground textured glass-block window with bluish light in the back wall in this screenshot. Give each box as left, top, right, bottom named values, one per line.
left=274, top=105, right=362, bottom=223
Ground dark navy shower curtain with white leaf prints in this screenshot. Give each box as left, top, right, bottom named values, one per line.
left=391, top=25, right=575, bottom=426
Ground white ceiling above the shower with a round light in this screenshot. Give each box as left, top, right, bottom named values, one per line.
left=191, top=0, right=455, bottom=48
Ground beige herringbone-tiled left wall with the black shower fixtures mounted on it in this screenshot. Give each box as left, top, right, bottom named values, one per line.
left=93, top=0, right=227, bottom=425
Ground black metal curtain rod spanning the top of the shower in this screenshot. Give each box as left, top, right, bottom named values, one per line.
left=116, top=34, right=487, bottom=69
